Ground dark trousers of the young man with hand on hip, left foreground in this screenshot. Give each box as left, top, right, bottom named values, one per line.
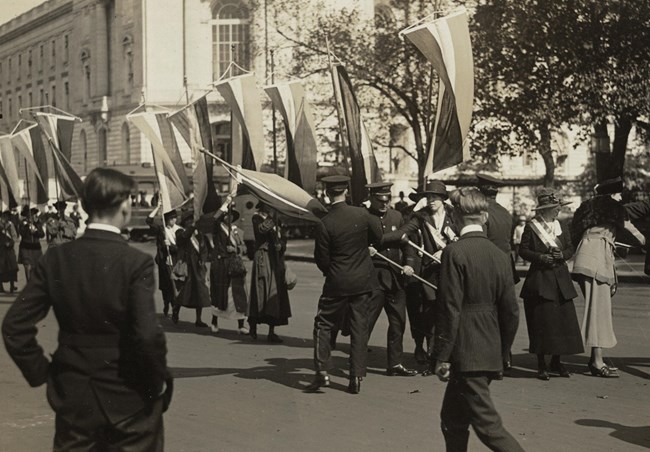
left=53, top=399, right=164, bottom=452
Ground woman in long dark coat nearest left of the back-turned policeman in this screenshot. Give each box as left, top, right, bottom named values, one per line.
left=248, top=203, right=291, bottom=343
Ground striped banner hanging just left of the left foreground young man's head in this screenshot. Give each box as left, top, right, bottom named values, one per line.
left=34, top=112, right=83, bottom=201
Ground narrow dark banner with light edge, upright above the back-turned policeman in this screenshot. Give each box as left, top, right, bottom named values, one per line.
left=332, top=65, right=381, bottom=205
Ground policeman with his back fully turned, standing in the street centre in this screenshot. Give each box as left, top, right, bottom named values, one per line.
left=306, top=176, right=382, bottom=394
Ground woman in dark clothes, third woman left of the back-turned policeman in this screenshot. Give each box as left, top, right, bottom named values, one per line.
left=172, top=212, right=210, bottom=327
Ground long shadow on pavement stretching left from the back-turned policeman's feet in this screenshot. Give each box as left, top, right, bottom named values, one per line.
left=171, top=356, right=348, bottom=391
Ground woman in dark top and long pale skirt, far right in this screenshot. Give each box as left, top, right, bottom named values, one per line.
left=571, top=178, right=627, bottom=378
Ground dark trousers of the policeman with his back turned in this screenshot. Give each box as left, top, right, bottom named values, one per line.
left=314, top=292, right=371, bottom=377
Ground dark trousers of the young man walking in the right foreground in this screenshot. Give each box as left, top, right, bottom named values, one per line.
left=440, top=373, right=523, bottom=452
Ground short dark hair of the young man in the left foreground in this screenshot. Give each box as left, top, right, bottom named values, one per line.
left=81, top=168, right=136, bottom=215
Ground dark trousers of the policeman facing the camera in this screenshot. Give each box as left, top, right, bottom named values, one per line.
left=368, top=289, right=406, bottom=369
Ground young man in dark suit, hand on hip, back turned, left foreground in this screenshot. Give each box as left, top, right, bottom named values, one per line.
left=2, top=168, right=172, bottom=451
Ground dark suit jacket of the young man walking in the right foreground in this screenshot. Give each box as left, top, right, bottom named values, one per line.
left=432, top=232, right=519, bottom=373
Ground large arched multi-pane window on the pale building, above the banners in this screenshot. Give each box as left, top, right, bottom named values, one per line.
left=211, top=0, right=250, bottom=80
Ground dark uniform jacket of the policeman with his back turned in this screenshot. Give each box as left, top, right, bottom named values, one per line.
left=314, top=202, right=381, bottom=297
